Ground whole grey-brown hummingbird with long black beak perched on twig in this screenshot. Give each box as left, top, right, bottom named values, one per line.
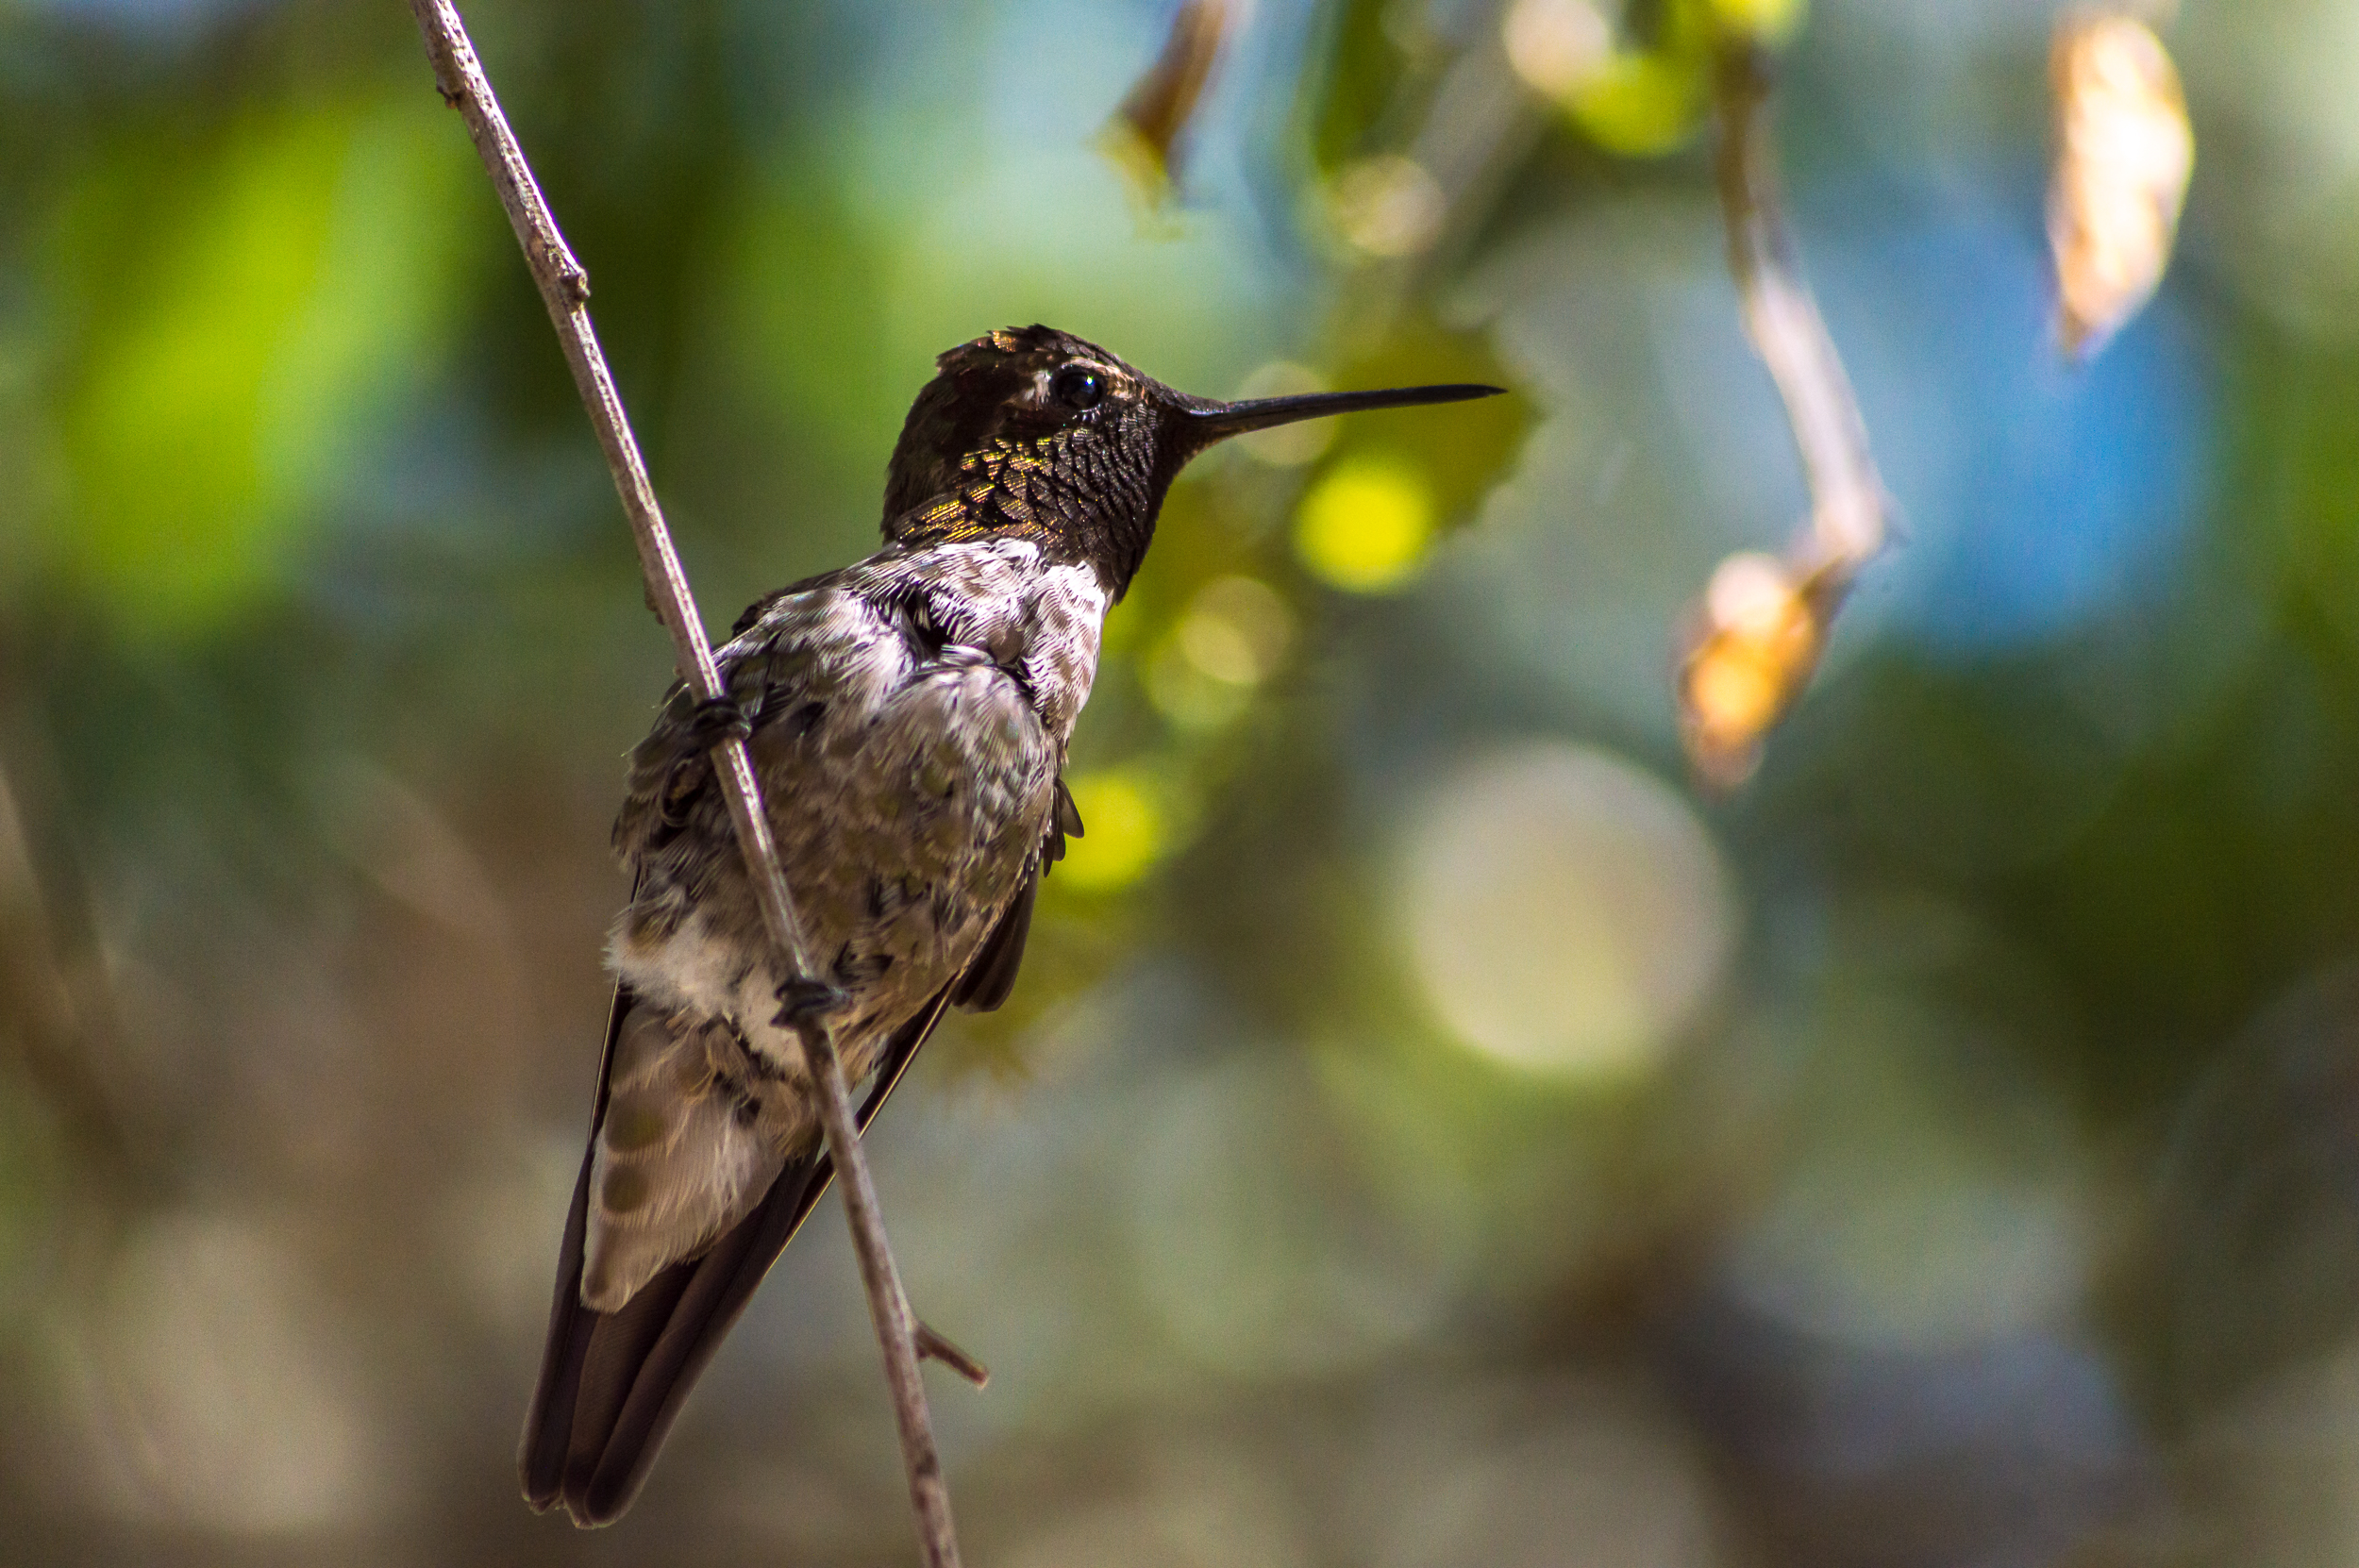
left=519, top=325, right=1500, bottom=1526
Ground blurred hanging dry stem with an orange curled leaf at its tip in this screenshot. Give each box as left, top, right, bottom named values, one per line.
left=1680, top=35, right=1890, bottom=788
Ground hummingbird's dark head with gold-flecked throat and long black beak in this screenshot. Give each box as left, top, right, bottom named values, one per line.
left=885, top=325, right=1500, bottom=599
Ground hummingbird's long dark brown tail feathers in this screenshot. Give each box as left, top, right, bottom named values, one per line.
left=517, top=986, right=951, bottom=1526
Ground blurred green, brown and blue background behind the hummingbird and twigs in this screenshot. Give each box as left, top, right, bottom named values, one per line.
left=0, top=0, right=2359, bottom=1568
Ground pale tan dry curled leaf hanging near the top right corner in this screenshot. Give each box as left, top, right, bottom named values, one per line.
left=2048, top=14, right=2197, bottom=356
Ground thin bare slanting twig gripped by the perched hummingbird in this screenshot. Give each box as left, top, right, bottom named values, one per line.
left=410, top=0, right=958, bottom=1568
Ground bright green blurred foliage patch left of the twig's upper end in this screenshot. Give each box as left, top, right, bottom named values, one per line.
left=52, top=94, right=486, bottom=639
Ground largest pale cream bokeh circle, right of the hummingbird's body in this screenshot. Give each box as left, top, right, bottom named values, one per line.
left=1399, top=742, right=1736, bottom=1077
